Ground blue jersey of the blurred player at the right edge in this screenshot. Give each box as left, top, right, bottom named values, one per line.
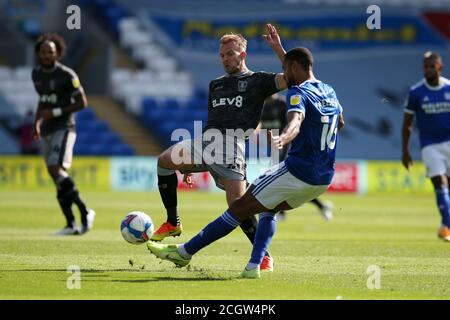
left=405, top=77, right=450, bottom=148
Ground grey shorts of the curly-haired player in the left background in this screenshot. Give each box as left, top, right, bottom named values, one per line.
left=42, top=129, right=77, bottom=169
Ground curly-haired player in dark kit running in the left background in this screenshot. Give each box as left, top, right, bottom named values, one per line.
left=32, top=33, right=95, bottom=235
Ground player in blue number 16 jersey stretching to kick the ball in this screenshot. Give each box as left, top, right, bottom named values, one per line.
left=147, top=44, right=344, bottom=278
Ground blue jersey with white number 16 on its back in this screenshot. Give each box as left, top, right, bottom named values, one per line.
left=285, top=80, right=342, bottom=185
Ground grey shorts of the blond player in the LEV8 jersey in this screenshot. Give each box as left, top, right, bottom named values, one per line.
left=174, top=135, right=246, bottom=189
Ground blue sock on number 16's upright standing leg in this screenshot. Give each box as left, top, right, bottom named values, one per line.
left=250, top=212, right=277, bottom=265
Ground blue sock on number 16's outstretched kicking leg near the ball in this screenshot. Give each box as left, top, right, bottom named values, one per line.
left=184, top=211, right=239, bottom=255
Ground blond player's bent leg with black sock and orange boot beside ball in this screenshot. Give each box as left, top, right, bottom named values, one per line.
left=151, top=140, right=199, bottom=241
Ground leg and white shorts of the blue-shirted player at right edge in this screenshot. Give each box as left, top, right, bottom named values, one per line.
left=422, top=142, right=450, bottom=241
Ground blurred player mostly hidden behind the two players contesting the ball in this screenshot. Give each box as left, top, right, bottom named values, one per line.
left=255, top=93, right=333, bottom=221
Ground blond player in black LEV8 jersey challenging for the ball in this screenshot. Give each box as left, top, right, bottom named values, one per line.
left=152, top=23, right=287, bottom=271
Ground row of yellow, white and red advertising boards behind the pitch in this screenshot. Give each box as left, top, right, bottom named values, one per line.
left=0, top=156, right=433, bottom=194
